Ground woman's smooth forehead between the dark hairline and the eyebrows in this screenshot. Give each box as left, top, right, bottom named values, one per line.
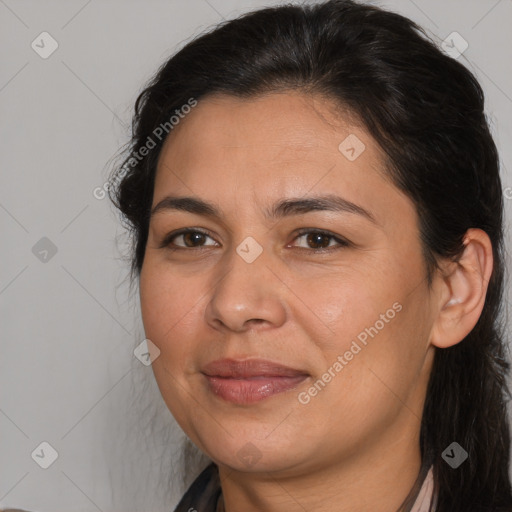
left=153, top=92, right=411, bottom=230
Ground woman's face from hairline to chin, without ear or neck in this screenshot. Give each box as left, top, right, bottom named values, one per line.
left=140, top=92, right=434, bottom=472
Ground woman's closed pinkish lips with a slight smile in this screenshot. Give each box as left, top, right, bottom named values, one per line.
left=202, top=359, right=309, bottom=405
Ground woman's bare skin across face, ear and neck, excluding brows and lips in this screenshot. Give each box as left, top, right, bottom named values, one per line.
left=140, top=92, right=492, bottom=512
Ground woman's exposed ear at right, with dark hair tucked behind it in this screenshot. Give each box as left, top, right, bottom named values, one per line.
left=430, top=229, right=493, bottom=348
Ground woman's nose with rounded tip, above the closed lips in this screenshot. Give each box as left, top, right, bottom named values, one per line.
left=205, top=243, right=286, bottom=332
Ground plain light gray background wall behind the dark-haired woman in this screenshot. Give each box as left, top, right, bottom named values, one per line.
left=0, top=0, right=512, bottom=512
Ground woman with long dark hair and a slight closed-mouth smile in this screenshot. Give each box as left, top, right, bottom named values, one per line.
left=110, top=0, right=512, bottom=512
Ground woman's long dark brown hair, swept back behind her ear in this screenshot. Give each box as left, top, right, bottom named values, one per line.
left=109, top=0, right=512, bottom=512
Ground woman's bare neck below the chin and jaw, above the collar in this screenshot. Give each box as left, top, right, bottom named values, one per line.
left=218, top=418, right=421, bottom=512
